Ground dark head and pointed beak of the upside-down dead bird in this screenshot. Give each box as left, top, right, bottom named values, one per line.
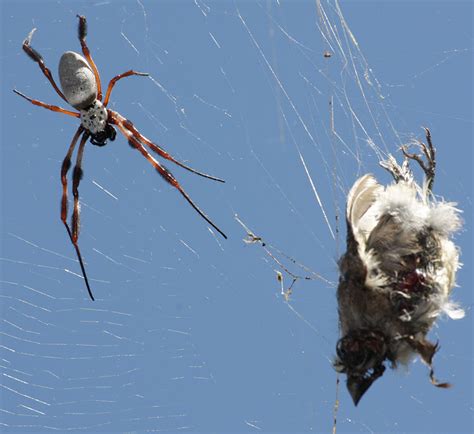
left=334, top=330, right=388, bottom=405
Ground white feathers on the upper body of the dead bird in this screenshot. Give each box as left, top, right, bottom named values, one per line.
left=347, top=169, right=464, bottom=319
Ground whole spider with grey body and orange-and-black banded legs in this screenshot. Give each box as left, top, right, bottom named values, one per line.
left=13, top=15, right=227, bottom=300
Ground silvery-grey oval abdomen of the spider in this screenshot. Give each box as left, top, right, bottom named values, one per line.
left=58, top=51, right=97, bottom=110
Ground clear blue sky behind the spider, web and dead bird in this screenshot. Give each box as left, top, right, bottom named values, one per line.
left=0, top=0, right=474, bottom=433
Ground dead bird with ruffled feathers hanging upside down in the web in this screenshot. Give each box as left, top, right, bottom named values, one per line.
left=334, top=129, right=464, bottom=404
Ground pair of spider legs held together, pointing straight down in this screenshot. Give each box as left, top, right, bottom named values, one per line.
left=61, top=126, right=94, bottom=300
